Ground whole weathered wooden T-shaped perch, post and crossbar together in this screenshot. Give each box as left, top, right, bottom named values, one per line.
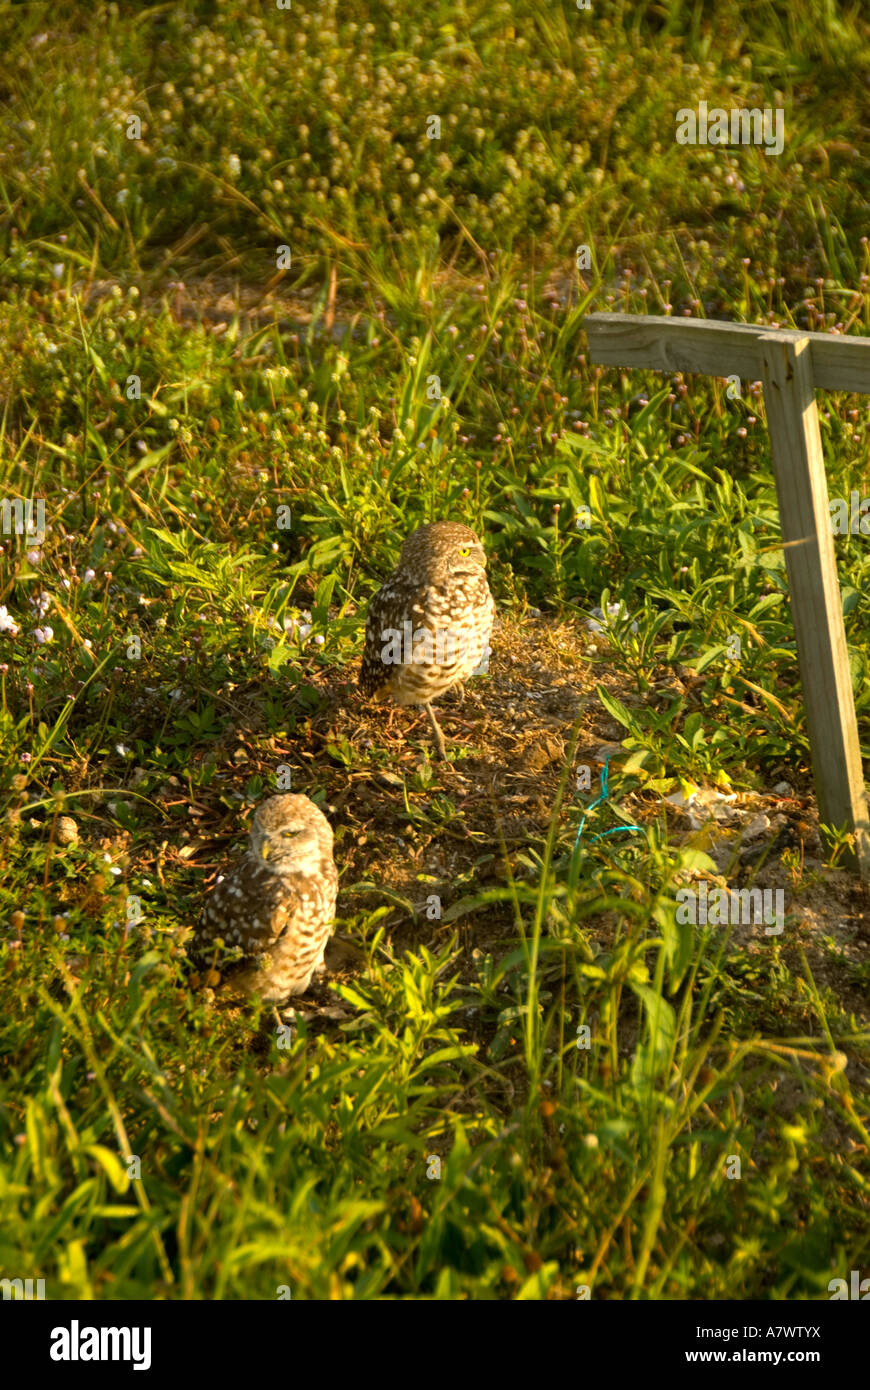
left=584, top=314, right=870, bottom=880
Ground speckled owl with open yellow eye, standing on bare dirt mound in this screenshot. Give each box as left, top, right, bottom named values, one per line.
left=360, top=521, right=495, bottom=760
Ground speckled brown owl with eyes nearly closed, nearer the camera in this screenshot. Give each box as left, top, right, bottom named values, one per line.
left=192, top=794, right=338, bottom=1004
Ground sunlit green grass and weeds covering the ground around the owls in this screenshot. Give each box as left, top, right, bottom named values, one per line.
left=0, top=0, right=870, bottom=1300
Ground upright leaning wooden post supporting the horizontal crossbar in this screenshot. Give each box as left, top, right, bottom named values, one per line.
left=759, top=332, right=870, bottom=877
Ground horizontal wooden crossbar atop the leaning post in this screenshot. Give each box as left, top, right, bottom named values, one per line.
left=584, top=314, right=870, bottom=393
